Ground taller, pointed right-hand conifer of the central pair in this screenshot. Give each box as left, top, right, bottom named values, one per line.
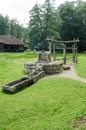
left=43, top=0, right=61, bottom=39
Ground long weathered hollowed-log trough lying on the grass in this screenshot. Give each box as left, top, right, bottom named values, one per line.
left=2, top=71, right=45, bottom=93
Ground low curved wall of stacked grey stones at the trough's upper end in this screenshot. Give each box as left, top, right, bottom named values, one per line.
left=24, top=62, right=63, bottom=74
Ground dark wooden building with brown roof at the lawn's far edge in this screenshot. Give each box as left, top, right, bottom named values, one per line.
left=0, top=35, right=24, bottom=52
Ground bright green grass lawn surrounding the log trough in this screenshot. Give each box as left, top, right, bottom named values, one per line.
left=0, top=53, right=86, bottom=130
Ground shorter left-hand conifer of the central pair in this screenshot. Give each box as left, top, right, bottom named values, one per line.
left=29, top=4, right=43, bottom=49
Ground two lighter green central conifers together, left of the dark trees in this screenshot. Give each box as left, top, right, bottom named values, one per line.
left=29, top=0, right=61, bottom=50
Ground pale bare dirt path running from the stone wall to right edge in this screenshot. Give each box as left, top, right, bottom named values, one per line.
left=46, top=64, right=86, bottom=83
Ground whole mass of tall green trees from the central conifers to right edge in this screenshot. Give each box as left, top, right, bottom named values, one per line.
left=29, top=0, right=86, bottom=52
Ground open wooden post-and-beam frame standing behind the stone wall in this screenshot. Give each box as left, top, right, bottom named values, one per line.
left=46, top=38, right=79, bottom=64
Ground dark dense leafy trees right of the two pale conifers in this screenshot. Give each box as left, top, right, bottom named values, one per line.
left=59, top=1, right=86, bottom=51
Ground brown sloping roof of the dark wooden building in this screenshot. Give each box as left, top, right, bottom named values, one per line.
left=0, top=35, right=24, bottom=45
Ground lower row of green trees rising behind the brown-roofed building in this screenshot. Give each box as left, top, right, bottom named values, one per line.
left=0, top=15, right=28, bottom=42
